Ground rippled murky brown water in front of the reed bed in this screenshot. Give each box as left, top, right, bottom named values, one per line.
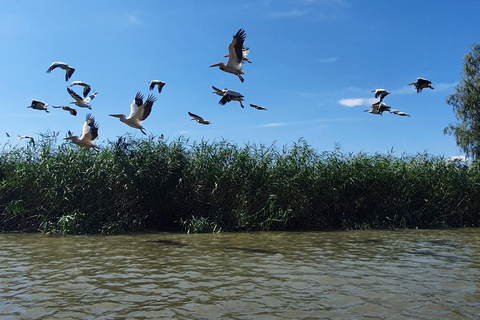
left=0, top=229, right=480, bottom=319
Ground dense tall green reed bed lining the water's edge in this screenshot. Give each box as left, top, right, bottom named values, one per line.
left=0, top=134, right=480, bottom=234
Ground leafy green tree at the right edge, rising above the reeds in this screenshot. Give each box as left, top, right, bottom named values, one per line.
left=443, top=44, right=480, bottom=159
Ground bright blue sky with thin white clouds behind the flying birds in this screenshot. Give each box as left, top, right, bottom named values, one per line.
left=0, top=0, right=480, bottom=157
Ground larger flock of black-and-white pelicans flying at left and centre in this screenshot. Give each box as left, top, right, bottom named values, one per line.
left=20, top=29, right=266, bottom=151
